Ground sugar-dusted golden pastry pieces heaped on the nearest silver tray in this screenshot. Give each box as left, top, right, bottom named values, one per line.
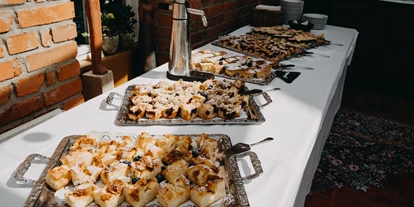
left=45, top=132, right=230, bottom=207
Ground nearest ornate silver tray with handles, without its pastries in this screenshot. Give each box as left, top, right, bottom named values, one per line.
left=14, top=134, right=263, bottom=207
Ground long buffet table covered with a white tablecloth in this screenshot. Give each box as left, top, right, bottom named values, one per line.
left=0, top=26, right=358, bottom=207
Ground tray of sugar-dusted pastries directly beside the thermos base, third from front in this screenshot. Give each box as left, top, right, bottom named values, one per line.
left=191, top=50, right=280, bottom=85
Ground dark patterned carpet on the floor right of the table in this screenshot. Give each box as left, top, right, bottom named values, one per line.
left=305, top=109, right=414, bottom=207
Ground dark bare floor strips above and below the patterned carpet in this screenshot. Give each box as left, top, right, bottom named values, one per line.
left=305, top=84, right=414, bottom=207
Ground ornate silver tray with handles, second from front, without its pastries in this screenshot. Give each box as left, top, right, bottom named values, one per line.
left=106, top=85, right=272, bottom=126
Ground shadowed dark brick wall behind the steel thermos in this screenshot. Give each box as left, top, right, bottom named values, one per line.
left=152, top=0, right=259, bottom=65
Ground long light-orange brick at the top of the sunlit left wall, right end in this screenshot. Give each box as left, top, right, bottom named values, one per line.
left=16, top=2, right=75, bottom=28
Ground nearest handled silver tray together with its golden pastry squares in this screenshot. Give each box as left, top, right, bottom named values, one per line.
left=14, top=132, right=263, bottom=207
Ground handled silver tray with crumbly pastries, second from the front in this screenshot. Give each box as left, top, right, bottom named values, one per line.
left=106, top=79, right=272, bottom=125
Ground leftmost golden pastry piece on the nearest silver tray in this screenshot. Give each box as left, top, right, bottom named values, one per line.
left=45, top=165, right=72, bottom=191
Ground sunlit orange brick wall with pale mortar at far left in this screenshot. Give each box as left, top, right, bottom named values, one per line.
left=0, top=0, right=84, bottom=134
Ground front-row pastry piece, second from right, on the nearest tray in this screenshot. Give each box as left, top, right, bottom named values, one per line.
left=156, top=175, right=190, bottom=207
